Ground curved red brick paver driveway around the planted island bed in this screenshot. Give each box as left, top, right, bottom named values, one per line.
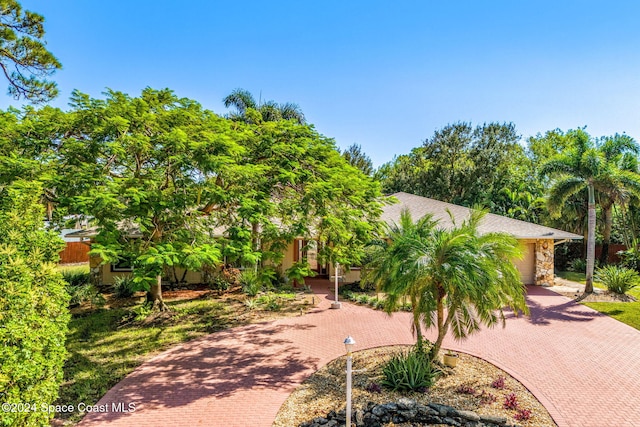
left=80, top=281, right=640, bottom=427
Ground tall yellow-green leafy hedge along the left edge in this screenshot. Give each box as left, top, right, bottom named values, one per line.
left=0, top=182, right=70, bottom=426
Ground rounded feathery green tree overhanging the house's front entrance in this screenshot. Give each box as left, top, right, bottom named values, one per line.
left=205, top=112, right=382, bottom=276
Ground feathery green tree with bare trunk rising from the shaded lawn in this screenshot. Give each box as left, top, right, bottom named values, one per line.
left=56, top=89, right=232, bottom=309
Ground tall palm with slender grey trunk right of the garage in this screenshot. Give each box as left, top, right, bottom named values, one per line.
left=540, top=129, right=640, bottom=297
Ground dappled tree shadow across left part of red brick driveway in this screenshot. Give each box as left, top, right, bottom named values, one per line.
left=78, top=325, right=320, bottom=422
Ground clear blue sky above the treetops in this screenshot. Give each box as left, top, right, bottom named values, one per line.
left=0, top=0, right=640, bottom=165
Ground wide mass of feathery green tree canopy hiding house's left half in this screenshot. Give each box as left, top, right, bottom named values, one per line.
left=0, top=88, right=382, bottom=308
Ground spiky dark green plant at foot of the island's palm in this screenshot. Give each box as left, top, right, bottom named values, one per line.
left=381, top=348, right=439, bottom=391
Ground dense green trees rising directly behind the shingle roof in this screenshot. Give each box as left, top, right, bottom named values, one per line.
left=377, top=123, right=538, bottom=214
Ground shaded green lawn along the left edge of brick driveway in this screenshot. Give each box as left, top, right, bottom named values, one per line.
left=58, top=288, right=307, bottom=424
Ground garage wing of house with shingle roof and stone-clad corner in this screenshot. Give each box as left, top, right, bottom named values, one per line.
left=340, top=192, right=582, bottom=286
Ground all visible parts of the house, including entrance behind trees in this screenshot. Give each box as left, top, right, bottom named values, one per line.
left=76, top=192, right=582, bottom=286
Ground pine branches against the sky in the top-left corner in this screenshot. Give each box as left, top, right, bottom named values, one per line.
left=0, top=0, right=62, bottom=102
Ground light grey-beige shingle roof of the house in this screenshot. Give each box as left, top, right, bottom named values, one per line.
left=382, top=192, right=583, bottom=240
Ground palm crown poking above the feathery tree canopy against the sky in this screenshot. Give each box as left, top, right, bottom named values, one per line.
left=222, top=89, right=306, bottom=124
